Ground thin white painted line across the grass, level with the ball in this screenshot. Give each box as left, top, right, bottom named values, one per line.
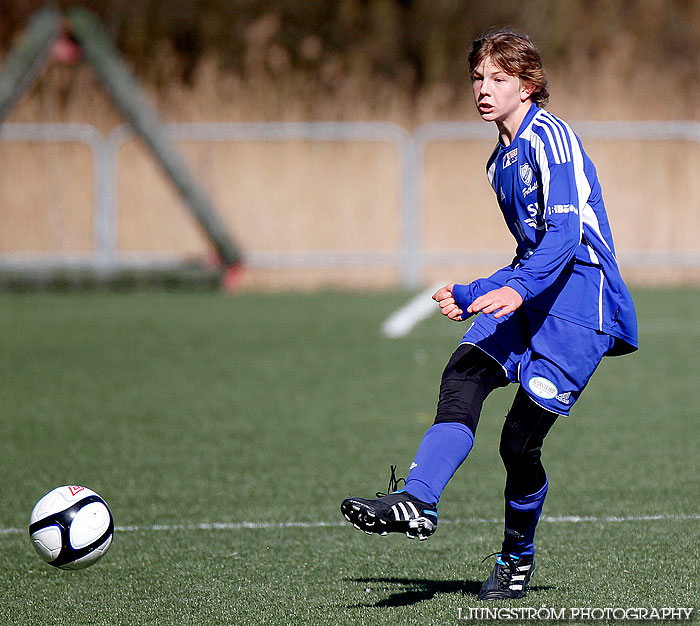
left=0, top=513, right=700, bottom=536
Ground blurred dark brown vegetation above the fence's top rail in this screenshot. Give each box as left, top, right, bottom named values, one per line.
left=0, top=0, right=700, bottom=127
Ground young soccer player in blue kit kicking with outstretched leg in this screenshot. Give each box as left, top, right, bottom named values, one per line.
left=341, top=30, right=637, bottom=600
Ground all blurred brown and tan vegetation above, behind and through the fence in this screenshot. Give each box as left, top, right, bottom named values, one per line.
left=0, top=0, right=700, bottom=286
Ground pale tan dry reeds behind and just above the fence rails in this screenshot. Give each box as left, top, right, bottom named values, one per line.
left=0, top=54, right=700, bottom=287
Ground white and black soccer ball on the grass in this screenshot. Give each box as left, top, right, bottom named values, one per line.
left=29, top=485, right=114, bottom=569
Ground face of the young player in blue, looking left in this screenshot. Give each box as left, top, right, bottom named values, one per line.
left=472, top=57, right=531, bottom=126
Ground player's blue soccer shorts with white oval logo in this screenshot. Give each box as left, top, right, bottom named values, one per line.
left=462, top=306, right=614, bottom=415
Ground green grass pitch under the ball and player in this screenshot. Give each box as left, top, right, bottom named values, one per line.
left=0, top=289, right=700, bottom=626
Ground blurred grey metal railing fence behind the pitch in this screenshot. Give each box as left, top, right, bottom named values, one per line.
left=0, top=122, right=700, bottom=288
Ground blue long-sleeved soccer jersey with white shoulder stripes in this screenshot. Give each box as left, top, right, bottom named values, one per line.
left=454, top=104, right=638, bottom=355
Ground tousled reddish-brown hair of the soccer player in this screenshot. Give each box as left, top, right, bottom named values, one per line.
left=469, top=28, right=549, bottom=107
